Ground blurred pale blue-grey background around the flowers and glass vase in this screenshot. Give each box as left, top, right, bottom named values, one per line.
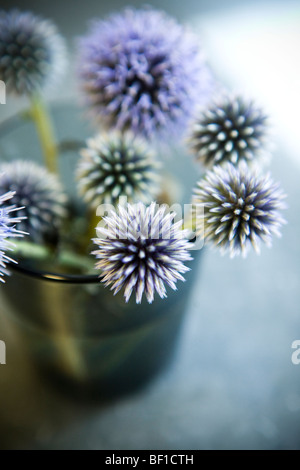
left=0, top=0, right=300, bottom=450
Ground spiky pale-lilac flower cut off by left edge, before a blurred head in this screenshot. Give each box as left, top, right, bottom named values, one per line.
left=0, top=191, right=24, bottom=282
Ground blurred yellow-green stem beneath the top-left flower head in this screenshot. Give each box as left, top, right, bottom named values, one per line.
left=30, top=95, right=58, bottom=173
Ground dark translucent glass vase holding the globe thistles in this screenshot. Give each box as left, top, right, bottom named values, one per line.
left=0, top=105, right=200, bottom=397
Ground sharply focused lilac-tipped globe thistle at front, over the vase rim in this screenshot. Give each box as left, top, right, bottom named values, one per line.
left=93, top=203, right=192, bottom=303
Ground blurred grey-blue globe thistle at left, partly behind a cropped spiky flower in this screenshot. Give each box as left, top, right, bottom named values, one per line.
left=0, top=160, right=66, bottom=241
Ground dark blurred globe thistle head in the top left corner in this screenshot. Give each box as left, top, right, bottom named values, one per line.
left=0, top=10, right=66, bottom=95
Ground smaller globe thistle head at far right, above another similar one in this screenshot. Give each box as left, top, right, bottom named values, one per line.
left=190, top=96, right=268, bottom=168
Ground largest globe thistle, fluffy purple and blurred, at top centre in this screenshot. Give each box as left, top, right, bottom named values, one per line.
left=79, top=9, right=212, bottom=137
